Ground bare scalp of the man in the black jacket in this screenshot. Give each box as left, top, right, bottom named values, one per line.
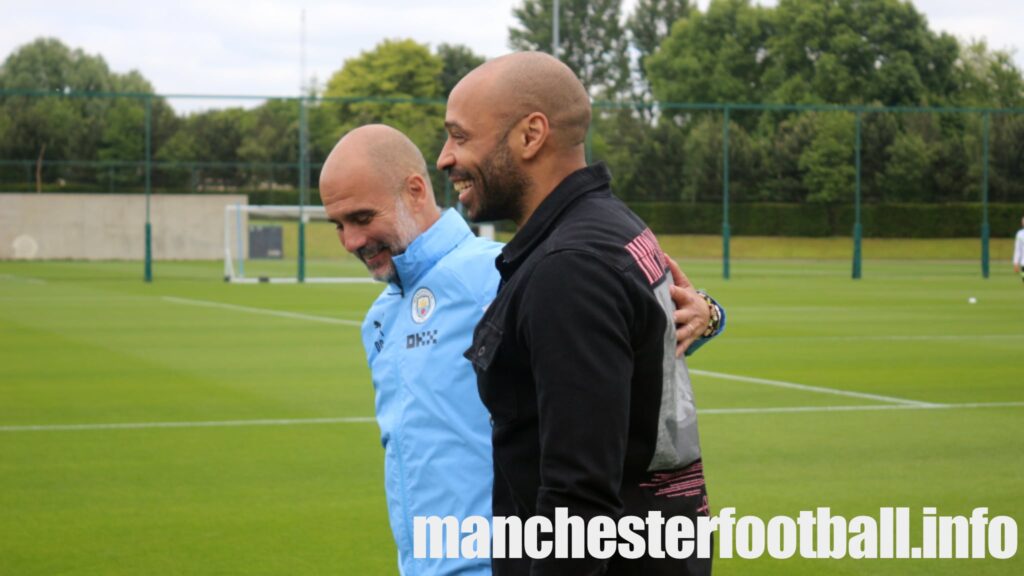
left=460, top=52, right=591, bottom=148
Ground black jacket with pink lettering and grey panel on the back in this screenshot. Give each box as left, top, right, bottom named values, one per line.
left=466, top=164, right=707, bottom=576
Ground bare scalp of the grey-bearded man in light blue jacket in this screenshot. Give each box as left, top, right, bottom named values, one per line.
left=321, top=124, right=432, bottom=194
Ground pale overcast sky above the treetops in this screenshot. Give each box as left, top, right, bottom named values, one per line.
left=0, top=0, right=1024, bottom=110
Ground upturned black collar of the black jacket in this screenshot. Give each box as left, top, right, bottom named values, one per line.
left=498, top=162, right=611, bottom=278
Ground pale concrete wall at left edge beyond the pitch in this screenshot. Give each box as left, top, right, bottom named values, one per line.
left=0, top=194, right=249, bottom=260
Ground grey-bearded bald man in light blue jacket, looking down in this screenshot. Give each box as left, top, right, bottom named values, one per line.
left=319, top=125, right=710, bottom=576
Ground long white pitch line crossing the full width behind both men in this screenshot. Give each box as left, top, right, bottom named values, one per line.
left=0, top=402, right=1024, bottom=433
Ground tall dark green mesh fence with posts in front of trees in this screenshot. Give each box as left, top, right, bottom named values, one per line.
left=0, top=90, right=1024, bottom=280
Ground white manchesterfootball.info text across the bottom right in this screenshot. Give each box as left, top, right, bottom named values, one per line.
left=413, top=507, right=1017, bottom=560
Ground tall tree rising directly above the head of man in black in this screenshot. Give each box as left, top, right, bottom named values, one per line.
left=509, top=0, right=630, bottom=98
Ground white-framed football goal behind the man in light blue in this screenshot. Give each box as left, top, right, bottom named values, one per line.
left=224, top=204, right=373, bottom=283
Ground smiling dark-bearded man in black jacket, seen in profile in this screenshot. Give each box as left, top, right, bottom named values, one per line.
left=437, top=52, right=719, bottom=576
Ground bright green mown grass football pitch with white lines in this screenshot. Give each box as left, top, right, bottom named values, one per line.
left=0, top=256, right=1024, bottom=576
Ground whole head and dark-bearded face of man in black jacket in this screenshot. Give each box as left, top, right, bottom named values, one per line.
left=437, top=52, right=591, bottom=225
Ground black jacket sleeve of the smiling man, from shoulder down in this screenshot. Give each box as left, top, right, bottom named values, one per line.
left=518, top=251, right=635, bottom=575
